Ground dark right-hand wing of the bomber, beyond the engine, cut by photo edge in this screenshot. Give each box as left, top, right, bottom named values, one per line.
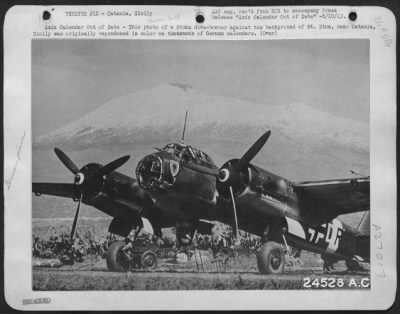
left=293, top=177, right=370, bottom=218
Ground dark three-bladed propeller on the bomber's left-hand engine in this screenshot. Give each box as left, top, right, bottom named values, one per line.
left=54, top=148, right=130, bottom=241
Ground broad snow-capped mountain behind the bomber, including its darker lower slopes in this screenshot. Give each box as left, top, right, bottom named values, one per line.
left=32, top=83, right=369, bottom=218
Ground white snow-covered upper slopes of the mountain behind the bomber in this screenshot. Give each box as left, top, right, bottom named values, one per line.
left=34, top=83, right=369, bottom=152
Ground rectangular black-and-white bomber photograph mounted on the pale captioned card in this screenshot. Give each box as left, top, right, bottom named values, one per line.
left=32, top=40, right=370, bottom=290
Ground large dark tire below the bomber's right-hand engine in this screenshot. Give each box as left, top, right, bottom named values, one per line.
left=257, top=241, right=285, bottom=274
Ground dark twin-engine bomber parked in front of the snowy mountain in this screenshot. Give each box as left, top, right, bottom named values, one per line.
left=33, top=122, right=370, bottom=273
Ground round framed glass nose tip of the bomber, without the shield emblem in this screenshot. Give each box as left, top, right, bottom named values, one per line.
left=136, top=154, right=164, bottom=189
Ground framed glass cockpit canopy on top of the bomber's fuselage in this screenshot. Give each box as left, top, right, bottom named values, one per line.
left=161, top=143, right=215, bottom=167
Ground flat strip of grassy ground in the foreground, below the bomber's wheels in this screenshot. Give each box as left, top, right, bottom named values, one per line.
left=33, top=269, right=369, bottom=290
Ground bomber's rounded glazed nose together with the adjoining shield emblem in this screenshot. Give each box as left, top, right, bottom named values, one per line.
left=136, top=153, right=179, bottom=189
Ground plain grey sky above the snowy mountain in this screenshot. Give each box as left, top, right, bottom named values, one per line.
left=32, top=39, right=370, bottom=137
